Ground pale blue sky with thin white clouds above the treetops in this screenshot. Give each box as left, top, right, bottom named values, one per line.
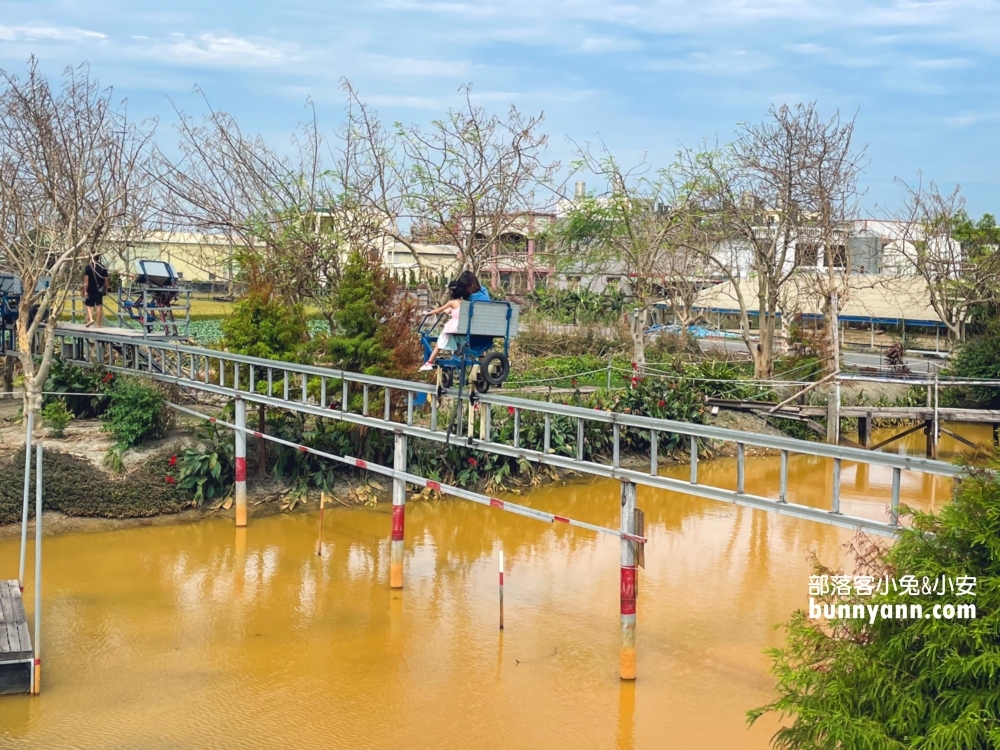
left=0, top=0, right=1000, bottom=215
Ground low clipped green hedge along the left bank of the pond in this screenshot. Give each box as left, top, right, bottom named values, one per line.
left=0, top=448, right=191, bottom=524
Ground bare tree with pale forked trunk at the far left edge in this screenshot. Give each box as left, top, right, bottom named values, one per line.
left=0, top=58, right=153, bottom=414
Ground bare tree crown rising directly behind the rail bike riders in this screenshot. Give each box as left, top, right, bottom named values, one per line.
left=343, top=81, right=558, bottom=274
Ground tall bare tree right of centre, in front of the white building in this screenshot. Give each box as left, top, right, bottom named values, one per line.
left=682, top=104, right=864, bottom=379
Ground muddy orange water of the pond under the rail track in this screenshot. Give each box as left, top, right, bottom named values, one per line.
left=0, top=426, right=976, bottom=750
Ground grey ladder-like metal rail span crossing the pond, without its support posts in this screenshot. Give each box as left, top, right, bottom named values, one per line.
left=50, top=330, right=965, bottom=535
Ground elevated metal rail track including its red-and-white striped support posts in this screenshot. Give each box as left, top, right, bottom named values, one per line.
left=0, top=325, right=964, bottom=685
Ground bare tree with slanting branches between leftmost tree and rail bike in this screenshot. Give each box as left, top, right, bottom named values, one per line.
left=158, top=94, right=362, bottom=326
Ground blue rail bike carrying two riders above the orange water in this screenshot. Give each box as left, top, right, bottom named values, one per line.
left=418, top=300, right=518, bottom=393
